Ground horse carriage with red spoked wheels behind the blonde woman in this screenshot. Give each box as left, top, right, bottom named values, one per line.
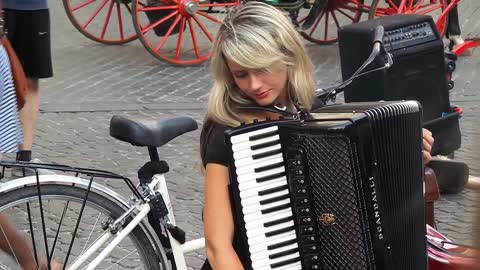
left=63, top=0, right=459, bottom=65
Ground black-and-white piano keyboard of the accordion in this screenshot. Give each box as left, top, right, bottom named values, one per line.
left=230, top=126, right=302, bottom=270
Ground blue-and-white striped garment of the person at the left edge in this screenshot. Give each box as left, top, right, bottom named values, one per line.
left=0, top=46, right=23, bottom=153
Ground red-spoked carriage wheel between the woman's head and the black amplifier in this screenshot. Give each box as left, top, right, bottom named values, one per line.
left=297, top=0, right=366, bottom=45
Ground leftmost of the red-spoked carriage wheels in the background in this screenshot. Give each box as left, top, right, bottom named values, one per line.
left=63, top=0, right=137, bottom=45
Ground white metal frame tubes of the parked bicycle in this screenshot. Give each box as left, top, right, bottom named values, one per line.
left=67, top=174, right=205, bottom=270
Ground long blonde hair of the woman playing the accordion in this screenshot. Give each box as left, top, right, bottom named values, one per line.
left=201, top=1, right=315, bottom=163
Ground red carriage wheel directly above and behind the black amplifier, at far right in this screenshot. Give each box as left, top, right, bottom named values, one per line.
left=368, top=0, right=448, bottom=37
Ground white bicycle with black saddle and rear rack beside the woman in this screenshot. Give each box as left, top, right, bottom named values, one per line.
left=0, top=116, right=205, bottom=270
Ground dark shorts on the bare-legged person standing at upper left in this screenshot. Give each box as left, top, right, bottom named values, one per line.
left=4, top=9, right=53, bottom=79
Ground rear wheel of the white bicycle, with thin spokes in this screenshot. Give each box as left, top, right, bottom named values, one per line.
left=0, top=184, right=167, bottom=270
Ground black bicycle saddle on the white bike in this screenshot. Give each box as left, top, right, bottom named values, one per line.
left=110, top=115, right=198, bottom=147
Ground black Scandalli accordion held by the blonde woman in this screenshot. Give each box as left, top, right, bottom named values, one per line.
left=225, top=101, right=427, bottom=270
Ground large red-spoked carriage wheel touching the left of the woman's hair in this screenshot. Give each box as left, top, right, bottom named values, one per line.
left=133, top=0, right=240, bottom=65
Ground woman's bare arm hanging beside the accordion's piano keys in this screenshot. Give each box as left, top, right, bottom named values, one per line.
left=203, top=163, right=243, bottom=270
